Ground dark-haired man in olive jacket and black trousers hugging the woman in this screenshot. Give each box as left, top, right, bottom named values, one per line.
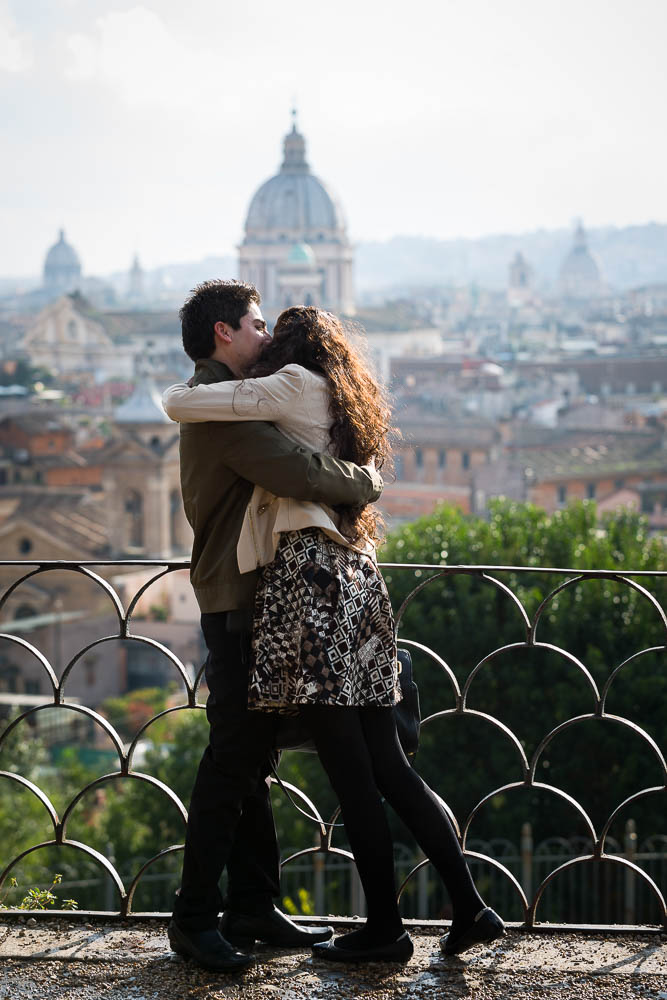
left=164, top=281, right=382, bottom=971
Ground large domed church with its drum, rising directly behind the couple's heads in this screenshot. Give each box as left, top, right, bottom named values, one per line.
left=239, top=115, right=354, bottom=316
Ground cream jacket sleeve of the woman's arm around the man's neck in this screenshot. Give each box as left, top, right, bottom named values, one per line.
left=162, top=365, right=304, bottom=424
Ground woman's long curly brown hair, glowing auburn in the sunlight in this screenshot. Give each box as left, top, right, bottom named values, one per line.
left=246, top=306, right=392, bottom=542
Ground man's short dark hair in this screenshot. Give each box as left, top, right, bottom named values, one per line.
left=178, top=278, right=261, bottom=361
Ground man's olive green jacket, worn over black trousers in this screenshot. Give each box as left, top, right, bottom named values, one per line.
left=180, top=358, right=382, bottom=613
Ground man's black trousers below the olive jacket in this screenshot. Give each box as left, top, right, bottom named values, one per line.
left=174, top=612, right=280, bottom=930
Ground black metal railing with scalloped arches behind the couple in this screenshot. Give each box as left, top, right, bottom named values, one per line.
left=0, top=560, right=667, bottom=930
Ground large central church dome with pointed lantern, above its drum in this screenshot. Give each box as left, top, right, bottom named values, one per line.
left=245, top=125, right=345, bottom=236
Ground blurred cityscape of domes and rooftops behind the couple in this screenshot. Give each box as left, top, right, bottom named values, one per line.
left=0, top=115, right=667, bottom=728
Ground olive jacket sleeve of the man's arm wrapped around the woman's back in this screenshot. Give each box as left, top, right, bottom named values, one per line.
left=211, top=421, right=384, bottom=506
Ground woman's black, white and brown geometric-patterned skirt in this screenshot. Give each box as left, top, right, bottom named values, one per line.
left=248, top=528, right=401, bottom=710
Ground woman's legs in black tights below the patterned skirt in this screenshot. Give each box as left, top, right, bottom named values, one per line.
left=302, top=705, right=484, bottom=947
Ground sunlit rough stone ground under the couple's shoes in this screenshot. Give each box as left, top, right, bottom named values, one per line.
left=0, top=920, right=667, bottom=1000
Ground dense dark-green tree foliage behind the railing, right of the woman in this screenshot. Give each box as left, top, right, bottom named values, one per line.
left=381, top=501, right=667, bottom=843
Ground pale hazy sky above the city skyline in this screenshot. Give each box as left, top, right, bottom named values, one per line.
left=0, top=0, right=667, bottom=275
